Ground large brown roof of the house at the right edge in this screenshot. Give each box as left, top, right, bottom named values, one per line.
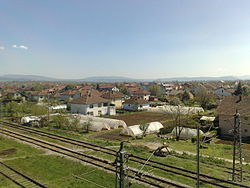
left=217, top=96, right=250, bottom=116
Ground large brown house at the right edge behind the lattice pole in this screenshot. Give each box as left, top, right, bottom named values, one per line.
left=217, top=96, right=250, bottom=139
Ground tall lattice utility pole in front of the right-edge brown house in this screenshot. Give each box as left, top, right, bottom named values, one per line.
left=232, top=110, right=243, bottom=181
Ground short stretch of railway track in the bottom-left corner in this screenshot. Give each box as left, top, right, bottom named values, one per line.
left=0, top=162, right=47, bottom=188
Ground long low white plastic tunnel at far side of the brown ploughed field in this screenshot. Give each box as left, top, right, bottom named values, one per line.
left=147, top=105, right=204, bottom=115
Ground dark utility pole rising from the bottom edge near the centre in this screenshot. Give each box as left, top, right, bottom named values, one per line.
left=115, top=141, right=129, bottom=188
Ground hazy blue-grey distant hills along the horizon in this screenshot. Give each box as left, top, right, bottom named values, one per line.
left=0, top=74, right=250, bottom=82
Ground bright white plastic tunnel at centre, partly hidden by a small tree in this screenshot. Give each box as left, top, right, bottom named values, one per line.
left=121, top=122, right=163, bottom=137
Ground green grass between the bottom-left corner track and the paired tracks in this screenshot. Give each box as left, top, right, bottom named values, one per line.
left=0, top=136, right=144, bottom=188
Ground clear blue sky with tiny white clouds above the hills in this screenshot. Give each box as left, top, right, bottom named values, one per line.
left=0, top=0, right=250, bottom=79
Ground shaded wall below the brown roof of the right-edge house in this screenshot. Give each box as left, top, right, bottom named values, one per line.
left=219, top=115, right=250, bottom=138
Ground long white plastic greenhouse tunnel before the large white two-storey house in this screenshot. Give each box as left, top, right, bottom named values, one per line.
left=74, top=114, right=127, bottom=131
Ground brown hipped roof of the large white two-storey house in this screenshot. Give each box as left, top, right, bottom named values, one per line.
left=70, top=94, right=108, bottom=104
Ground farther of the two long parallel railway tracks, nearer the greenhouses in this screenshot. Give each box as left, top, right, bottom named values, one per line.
left=0, top=121, right=249, bottom=188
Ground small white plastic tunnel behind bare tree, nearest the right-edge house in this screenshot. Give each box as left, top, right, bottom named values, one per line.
left=171, top=127, right=204, bottom=140
